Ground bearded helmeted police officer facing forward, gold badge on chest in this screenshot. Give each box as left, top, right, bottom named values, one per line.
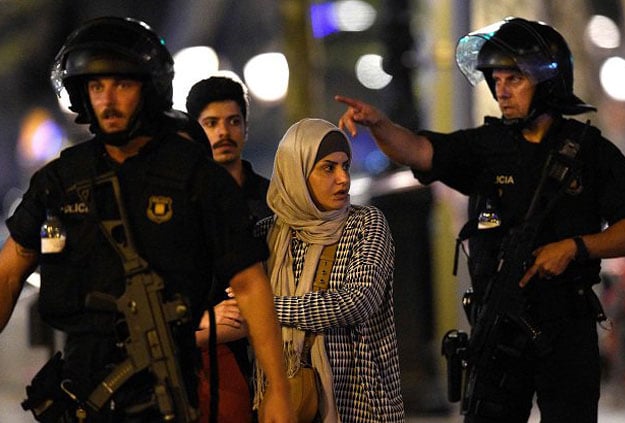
left=0, top=17, right=293, bottom=422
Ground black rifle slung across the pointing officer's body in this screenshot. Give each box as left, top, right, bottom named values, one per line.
left=442, top=125, right=588, bottom=414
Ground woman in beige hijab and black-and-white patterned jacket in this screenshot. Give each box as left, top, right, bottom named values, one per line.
left=256, top=119, right=404, bottom=423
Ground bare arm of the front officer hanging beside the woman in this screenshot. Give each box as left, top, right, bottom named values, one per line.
left=230, top=263, right=295, bottom=423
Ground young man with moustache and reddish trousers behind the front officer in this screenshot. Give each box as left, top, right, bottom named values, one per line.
left=186, top=76, right=271, bottom=423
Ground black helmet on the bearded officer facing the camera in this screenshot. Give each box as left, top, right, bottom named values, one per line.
left=50, top=17, right=174, bottom=123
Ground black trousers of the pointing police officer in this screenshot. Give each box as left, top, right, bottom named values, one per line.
left=464, top=314, right=600, bottom=423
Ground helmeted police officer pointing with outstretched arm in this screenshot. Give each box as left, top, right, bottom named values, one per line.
left=336, top=18, right=625, bottom=423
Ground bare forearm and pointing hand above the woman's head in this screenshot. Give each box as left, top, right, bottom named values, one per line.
left=334, top=95, right=433, bottom=172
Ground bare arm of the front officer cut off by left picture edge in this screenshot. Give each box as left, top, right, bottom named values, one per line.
left=0, top=237, right=39, bottom=332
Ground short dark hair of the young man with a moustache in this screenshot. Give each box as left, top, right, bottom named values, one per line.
left=187, top=76, right=249, bottom=122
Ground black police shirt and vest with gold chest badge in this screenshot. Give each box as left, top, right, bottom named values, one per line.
left=7, top=130, right=267, bottom=420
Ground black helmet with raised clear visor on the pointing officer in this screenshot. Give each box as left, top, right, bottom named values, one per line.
left=456, top=17, right=596, bottom=115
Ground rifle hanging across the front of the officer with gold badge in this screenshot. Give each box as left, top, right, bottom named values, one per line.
left=76, top=173, right=199, bottom=423
